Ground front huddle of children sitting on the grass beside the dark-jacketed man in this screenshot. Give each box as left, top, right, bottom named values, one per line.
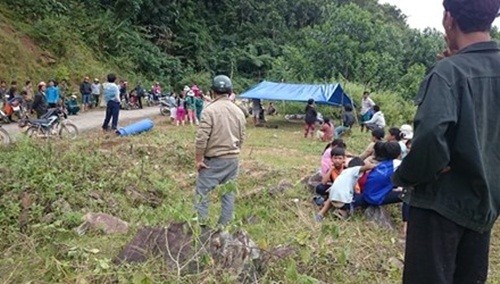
left=314, top=125, right=413, bottom=234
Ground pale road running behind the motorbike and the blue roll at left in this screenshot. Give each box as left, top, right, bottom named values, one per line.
left=2, top=106, right=160, bottom=138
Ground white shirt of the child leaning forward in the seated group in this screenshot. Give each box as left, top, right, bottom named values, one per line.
left=329, top=166, right=362, bottom=203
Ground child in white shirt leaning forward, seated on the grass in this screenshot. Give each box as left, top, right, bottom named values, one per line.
left=315, top=157, right=375, bottom=222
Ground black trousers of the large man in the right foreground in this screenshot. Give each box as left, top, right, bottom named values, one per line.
left=403, top=207, right=491, bottom=284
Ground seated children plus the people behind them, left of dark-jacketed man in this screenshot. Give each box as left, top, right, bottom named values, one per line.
left=296, top=92, right=413, bottom=234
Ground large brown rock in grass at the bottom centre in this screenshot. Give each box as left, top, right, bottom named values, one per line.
left=114, top=223, right=293, bottom=283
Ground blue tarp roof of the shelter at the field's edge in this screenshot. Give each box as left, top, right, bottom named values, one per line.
left=240, top=81, right=352, bottom=106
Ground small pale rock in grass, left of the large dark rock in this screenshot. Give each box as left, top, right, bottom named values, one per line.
left=75, top=213, right=128, bottom=235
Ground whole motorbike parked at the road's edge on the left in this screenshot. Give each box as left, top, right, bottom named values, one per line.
left=18, top=107, right=78, bottom=139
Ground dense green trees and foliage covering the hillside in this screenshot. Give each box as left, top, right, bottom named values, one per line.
left=5, top=0, right=500, bottom=94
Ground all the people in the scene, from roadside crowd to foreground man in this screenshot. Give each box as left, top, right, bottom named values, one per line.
left=0, top=0, right=500, bottom=283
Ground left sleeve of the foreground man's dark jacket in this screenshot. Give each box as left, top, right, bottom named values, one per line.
left=392, top=74, right=458, bottom=186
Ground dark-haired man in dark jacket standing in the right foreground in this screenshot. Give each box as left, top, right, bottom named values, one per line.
left=393, top=0, right=500, bottom=283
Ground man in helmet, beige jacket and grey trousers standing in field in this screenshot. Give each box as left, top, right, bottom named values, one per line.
left=195, top=75, right=246, bottom=226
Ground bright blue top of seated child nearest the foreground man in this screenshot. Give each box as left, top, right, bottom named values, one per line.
left=363, top=160, right=395, bottom=205
